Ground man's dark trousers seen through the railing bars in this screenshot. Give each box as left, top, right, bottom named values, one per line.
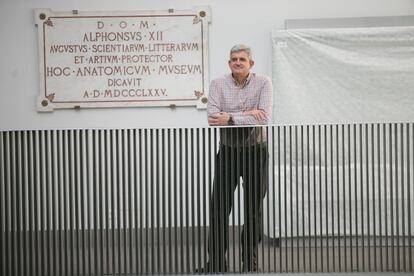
left=208, top=144, right=269, bottom=272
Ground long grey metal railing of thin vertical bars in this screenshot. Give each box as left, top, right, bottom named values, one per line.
left=0, top=123, right=414, bottom=275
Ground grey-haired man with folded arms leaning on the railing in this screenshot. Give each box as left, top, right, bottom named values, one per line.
left=203, top=45, right=272, bottom=272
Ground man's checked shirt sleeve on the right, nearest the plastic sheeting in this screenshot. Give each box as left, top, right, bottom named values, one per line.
left=231, top=77, right=273, bottom=125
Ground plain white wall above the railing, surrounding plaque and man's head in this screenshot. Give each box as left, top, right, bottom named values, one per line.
left=0, top=0, right=414, bottom=130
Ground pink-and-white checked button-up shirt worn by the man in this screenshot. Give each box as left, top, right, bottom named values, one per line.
left=207, top=73, right=273, bottom=146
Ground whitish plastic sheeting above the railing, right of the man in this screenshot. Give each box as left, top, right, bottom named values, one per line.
left=272, top=27, right=414, bottom=124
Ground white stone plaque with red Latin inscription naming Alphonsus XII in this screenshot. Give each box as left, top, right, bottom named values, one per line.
left=34, top=7, right=211, bottom=111
